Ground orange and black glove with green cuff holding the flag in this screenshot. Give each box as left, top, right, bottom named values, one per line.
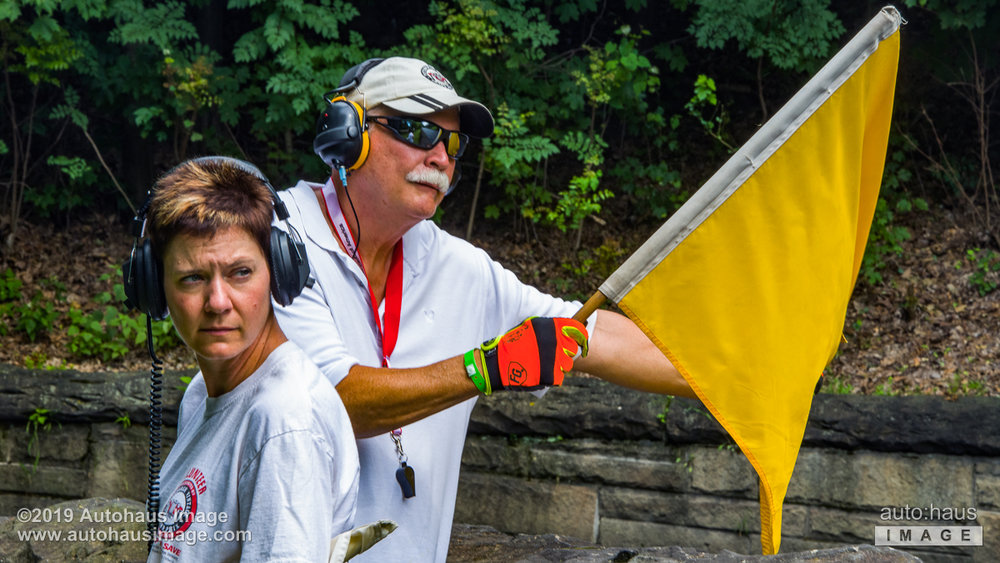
left=465, top=317, right=588, bottom=395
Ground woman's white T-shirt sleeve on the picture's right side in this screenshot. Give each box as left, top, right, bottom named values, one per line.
left=237, top=430, right=335, bottom=561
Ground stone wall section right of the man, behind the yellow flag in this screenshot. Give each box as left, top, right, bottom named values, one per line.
left=456, top=378, right=1000, bottom=561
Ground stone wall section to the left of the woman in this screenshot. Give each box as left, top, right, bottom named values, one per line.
left=0, top=364, right=191, bottom=516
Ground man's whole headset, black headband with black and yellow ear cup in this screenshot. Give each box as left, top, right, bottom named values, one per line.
left=313, top=58, right=385, bottom=170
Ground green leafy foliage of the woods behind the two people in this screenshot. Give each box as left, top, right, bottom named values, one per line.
left=0, top=0, right=997, bottom=334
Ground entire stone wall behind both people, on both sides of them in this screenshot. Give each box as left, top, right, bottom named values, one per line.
left=0, top=365, right=1000, bottom=561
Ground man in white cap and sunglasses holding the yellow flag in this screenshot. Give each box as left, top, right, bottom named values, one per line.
left=276, top=57, right=693, bottom=561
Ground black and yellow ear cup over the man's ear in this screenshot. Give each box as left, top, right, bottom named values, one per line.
left=313, top=97, right=368, bottom=170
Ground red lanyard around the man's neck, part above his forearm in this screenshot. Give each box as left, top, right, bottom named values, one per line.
left=323, top=184, right=403, bottom=367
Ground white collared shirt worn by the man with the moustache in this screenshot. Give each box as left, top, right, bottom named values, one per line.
left=275, top=181, right=580, bottom=561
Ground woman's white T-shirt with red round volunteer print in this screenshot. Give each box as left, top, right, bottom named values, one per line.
left=149, top=342, right=358, bottom=561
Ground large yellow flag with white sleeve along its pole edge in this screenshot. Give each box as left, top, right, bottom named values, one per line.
left=600, top=7, right=901, bottom=554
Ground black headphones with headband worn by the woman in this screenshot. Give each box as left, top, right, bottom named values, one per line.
left=122, top=156, right=312, bottom=320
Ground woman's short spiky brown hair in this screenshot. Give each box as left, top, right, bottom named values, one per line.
left=147, top=158, right=274, bottom=261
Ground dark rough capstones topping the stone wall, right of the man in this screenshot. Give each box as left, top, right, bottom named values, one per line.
left=469, top=377, right=1000, bottom=456
